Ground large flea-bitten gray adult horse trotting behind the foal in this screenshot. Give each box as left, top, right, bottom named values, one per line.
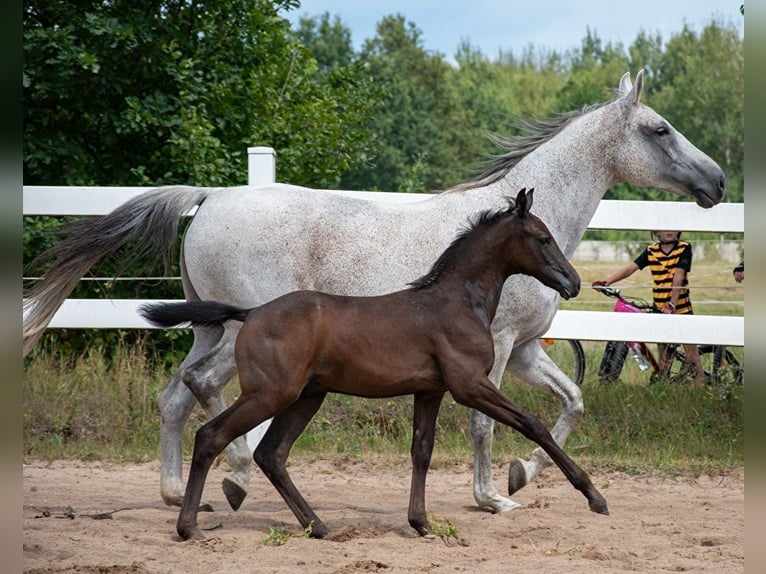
left=24, top=71, right=725, bottom=511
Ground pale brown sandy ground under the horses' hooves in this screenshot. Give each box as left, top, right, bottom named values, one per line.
left=23, top=461, right=745, bottom=574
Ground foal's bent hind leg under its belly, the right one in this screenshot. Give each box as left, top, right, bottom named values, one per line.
left=253, top=392, right=328, bottom=538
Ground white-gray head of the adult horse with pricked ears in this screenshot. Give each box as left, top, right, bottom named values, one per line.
left=613, top=70, right=726, bottom=208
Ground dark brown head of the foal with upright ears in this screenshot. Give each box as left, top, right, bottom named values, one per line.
left=507, top=188, right=580, bottom=299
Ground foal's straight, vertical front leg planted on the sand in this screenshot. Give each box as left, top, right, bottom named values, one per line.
left=407, top=393, right=444, bottom=536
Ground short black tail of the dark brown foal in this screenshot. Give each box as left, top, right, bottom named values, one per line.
left=138, top=301, right=250, bottom=328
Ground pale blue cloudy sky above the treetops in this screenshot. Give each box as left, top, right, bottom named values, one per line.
left=286, top=0, right=744, bottom=62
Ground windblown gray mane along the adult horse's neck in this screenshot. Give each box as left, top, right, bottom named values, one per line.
left=447, top=100, right=612, bottom=193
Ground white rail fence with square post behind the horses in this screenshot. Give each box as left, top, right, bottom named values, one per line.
left=23, top=147, right=745, bottom=346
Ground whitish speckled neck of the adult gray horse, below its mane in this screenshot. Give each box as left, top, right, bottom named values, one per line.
left=472, top=108, right=617, bottom=257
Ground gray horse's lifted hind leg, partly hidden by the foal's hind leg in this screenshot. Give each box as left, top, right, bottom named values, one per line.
left=181, top=325, right=252, bottom=510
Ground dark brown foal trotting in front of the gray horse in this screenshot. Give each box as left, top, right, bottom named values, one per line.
left=142, top=190, right=608, bottom=539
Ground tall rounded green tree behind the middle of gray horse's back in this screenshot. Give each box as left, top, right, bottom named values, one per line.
left=343, top=15, right=464, bottom=191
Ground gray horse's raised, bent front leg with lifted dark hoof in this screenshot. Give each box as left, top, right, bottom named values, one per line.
left=508, top=340, right=584, bottom=494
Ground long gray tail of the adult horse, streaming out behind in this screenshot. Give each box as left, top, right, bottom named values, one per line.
left=23, top=186, right=211, bottom=356
